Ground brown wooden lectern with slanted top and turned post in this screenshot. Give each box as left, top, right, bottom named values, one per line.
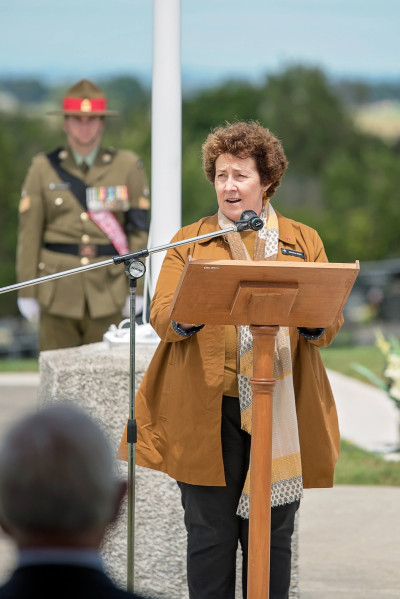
left=170, top=257, right=360, bottom=599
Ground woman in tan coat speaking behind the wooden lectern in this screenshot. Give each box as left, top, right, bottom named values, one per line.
left=119, top=122, right=342, bottom=599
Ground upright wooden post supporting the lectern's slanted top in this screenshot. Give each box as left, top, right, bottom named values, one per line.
left=247, top=326, right=279, bottom=599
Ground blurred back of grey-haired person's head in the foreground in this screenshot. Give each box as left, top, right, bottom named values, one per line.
left=0, top=403, right=126, bottom=546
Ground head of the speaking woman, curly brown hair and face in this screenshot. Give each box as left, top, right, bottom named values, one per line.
left=202, top=121, right=288, bottom=220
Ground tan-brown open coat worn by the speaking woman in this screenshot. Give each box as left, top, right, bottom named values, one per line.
left=118, top=215, right=342, bottom=488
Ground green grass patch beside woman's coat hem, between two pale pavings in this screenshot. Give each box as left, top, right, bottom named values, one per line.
left=335, top=441, right=400, bottom=486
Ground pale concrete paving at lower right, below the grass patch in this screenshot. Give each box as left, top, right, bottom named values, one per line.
left=299, top=485, right=400, bottom=599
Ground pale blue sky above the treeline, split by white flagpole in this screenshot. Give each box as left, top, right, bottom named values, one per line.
left=0, top=0, right=400, bottom=81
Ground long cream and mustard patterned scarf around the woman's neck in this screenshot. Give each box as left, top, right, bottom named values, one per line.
left=218, top=198, right=303, bottom=518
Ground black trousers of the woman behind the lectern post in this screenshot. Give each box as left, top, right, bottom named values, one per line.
left=178, top=397, right=299, bottom=599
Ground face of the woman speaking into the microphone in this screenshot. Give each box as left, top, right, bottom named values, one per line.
left=214, top=154, right=270, bottom=221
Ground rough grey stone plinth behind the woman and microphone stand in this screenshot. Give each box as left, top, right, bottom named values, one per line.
left=39, top=343, right=299, bottom=599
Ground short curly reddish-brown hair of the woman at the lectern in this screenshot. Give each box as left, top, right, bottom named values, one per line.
left=202, top=121, right=288, bottom=197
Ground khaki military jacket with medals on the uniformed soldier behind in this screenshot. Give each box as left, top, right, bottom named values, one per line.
left=17, top=148, right=149, bottom=318
